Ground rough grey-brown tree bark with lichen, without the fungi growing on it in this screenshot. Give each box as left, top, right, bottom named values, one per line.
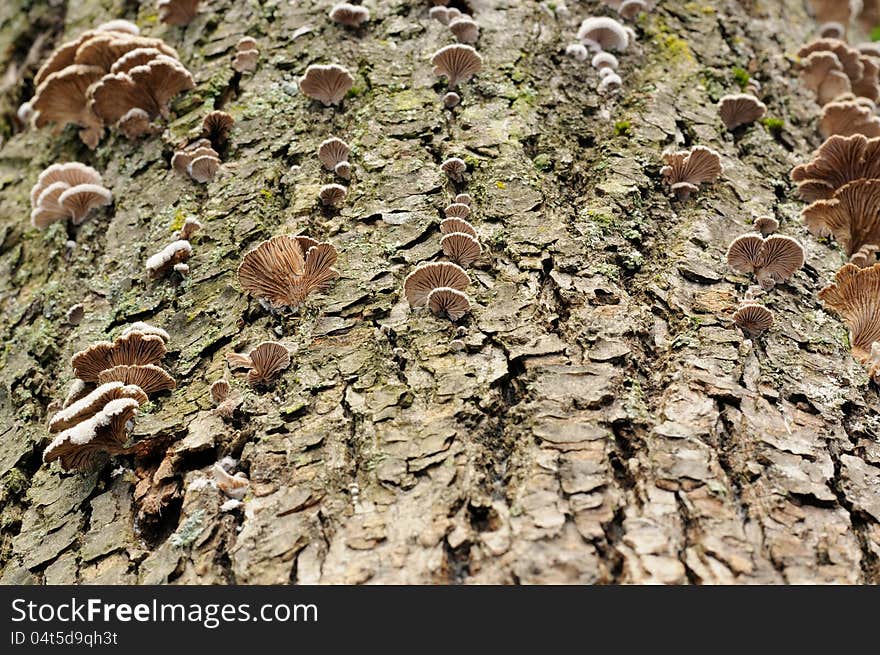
left=0, top=0, right=880, bottom=584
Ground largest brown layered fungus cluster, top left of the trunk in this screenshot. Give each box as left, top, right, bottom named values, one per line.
left=28, top=21, right=195, bottom=149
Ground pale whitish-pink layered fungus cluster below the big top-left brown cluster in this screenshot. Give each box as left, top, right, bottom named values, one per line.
left=31, top=162, right=113, bottom=228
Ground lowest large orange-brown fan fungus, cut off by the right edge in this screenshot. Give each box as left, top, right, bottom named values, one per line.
left=819, top=264, right=880, bottom=364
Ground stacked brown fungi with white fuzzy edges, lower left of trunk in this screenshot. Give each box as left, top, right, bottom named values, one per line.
left=43, top=323, right=176, bottom=471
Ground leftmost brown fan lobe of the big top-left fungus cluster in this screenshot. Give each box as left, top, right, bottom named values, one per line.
left=30, top=64, right=104, bottom=150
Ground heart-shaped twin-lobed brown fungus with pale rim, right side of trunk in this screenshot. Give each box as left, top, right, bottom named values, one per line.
left=727, top=234, right=804, bottom=289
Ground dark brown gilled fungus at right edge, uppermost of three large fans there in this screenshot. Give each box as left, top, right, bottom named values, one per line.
left=791, top=134, right=880, bottom=202
